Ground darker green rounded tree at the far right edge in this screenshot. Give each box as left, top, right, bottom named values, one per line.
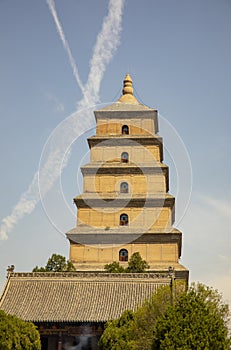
left=152, top=284, right=230, bottom=350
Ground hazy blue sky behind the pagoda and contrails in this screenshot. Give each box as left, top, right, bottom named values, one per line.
left=0, top=0, right=231, bottom=301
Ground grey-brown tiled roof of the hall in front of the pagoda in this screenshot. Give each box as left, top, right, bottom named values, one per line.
left=0, top=272, right=171, bottom=322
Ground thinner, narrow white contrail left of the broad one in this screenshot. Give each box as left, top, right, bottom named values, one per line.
left=47, top=0, right=84, bottom=93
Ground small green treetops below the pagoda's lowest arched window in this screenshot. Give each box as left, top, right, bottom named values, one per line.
left=104, top=252, right=149, bottom=273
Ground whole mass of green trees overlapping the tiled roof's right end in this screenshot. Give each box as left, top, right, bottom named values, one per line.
left=99, top=284, right=230, bottom=350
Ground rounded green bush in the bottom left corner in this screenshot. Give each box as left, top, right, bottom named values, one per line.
left=0, top=310, right=41, bottom=350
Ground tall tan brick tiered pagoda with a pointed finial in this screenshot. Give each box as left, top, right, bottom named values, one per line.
left=67, top=74, right=188, bottom=280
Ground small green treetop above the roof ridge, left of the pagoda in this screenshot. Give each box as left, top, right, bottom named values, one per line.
left=33, top=254, right=75, bottom=272
